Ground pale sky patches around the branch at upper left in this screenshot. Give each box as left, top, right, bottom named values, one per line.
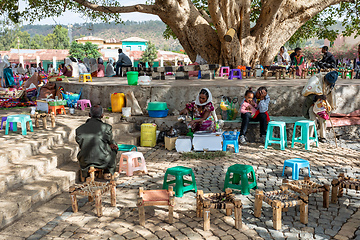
left=20, top=0, right=160, bottom=25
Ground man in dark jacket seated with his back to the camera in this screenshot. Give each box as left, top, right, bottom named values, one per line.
left=76, top=105, right=118, bottom=178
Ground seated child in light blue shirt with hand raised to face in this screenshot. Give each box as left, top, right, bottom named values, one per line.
left=239, top=87, right=270, bottom=144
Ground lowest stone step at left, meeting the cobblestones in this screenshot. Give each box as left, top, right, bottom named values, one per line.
left=0, top=162, right=77, bottom=229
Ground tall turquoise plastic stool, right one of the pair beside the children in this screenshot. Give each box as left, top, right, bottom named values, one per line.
left=291, top=120, right=319, bottom=150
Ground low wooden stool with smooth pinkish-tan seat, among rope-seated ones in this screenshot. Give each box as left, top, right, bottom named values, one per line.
left=137, top=186, right=175, bottom=226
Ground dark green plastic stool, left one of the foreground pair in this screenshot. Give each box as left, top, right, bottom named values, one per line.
left=163, top=166, right=197, bottom=197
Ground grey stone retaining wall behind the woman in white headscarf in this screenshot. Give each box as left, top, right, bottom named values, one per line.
left=61, top=80, right=360, bottom=116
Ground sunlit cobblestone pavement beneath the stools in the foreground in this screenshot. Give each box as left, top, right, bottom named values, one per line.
left=0, top=144, right=360, bottom=240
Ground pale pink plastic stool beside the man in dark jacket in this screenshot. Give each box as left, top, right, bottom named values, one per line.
left=119, top=152, right=147, bottom=176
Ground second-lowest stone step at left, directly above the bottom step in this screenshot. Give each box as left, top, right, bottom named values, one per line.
left=0, top=143, right=78, bottom=193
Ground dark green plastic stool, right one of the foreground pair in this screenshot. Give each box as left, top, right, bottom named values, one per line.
left=224, top=164, right=257, bottom=195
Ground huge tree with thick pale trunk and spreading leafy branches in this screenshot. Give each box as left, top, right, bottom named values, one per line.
left=0, top=0, right=360, bottom=66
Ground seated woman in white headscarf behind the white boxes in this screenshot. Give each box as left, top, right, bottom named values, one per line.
left=180, top=88, right=216, bottom=132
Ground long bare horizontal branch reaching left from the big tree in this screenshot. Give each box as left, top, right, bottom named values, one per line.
left=73, top=0, right=158, bottom=15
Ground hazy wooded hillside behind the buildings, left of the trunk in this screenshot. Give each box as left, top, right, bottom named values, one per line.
left=21, top=21, right=182, bottom=51
